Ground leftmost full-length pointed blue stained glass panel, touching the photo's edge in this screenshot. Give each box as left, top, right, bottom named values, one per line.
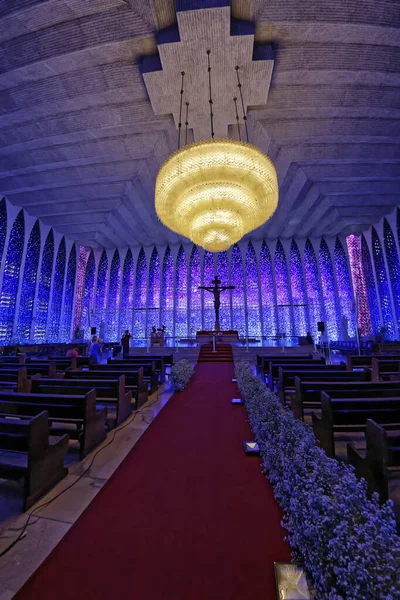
left=0, top=210, right=25, bottom=344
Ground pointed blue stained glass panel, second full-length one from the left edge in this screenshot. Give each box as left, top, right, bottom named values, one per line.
left=17, top=221, right=40, bottom=342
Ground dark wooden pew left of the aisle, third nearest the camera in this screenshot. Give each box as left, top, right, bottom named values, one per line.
left=32, top=375, right=133, bottom=426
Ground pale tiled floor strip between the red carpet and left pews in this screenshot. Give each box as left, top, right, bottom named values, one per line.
left=0, top=383, right=172, bottom=600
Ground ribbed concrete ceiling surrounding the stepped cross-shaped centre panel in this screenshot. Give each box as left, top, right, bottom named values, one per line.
left=0, top=0, right=400, bottom=248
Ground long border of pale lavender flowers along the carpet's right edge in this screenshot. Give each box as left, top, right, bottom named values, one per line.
left=236, top=363, right=400, bottom=600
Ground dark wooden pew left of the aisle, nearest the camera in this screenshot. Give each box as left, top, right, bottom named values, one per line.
left=0, top=411, right=68, bottom=511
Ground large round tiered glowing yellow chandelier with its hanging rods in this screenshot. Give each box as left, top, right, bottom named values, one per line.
left=155, top=51, right=278, bottom=252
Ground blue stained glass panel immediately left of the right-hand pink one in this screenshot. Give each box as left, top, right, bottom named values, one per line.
left=333, top=238, right=356, bottom=339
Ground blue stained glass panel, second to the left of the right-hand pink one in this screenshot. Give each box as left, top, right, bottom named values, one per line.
left=319, top=238, right=340, bottom=340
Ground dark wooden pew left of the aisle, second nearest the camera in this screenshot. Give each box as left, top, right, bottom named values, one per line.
left=0, top=389, right=107, bottom=459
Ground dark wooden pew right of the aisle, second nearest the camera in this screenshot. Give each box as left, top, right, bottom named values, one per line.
left=312, top=392, right=400, bottom=458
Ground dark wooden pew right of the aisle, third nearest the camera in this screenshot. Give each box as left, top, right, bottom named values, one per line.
left=291, top=380, right=400, bottom=420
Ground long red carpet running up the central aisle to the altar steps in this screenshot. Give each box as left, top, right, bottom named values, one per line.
left=16, top=364, right=290, bottom=600
